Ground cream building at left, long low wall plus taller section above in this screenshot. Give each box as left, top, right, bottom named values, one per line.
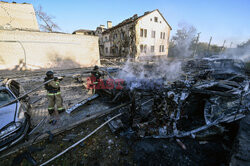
left=0, top=2, right=100, bottom=70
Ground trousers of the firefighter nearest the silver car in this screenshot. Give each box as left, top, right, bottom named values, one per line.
left=48, top=92, right=65, bottom=115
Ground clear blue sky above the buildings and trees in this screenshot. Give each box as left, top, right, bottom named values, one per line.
left=5, top=0, right=250, bottom=46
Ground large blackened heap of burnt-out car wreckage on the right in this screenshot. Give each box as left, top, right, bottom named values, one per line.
left=104, top=58, right=250, bottom=139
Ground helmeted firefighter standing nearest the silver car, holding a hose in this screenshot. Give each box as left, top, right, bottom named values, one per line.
left=44, top=71, right=65, bottom=115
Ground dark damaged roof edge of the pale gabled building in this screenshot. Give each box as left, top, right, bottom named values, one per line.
left=103, top=9, right=172, bottom=34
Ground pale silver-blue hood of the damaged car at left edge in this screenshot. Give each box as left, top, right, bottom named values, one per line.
left=0, top=103, right=17, bottom=130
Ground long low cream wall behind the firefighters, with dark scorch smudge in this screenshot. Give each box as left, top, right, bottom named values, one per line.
left=0, top=30, right=100, bottom=69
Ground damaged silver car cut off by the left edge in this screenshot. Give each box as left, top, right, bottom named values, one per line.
left=0, top=79, right=30, bottom=151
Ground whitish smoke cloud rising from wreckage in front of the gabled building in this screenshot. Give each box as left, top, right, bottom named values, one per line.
left=117, top=57, right=182, bottom=89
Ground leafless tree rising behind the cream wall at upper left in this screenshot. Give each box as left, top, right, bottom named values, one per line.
left=36, top=6, right=60, bottom=32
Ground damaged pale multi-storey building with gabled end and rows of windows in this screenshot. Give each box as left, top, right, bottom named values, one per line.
left=97, top=9, right=172, bottom=58
